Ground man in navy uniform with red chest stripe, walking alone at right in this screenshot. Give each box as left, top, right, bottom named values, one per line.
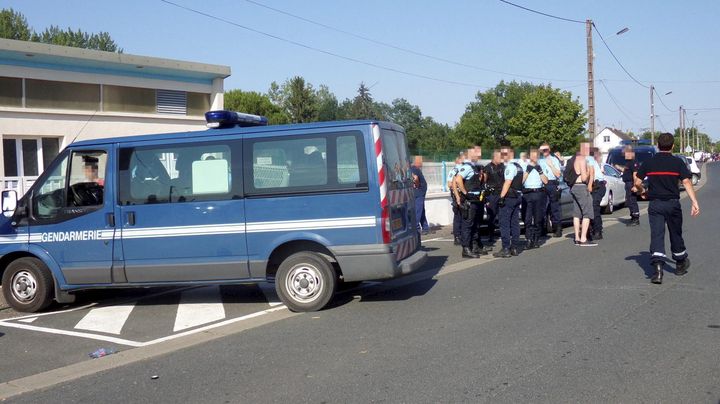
left=635, top=133, right=700, bottom=284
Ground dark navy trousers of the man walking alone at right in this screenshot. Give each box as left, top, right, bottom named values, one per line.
left=648, top=199, right=688, bottom=263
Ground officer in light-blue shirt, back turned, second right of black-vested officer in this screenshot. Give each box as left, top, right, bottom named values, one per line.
left=523, top=149, right=548, bottom=250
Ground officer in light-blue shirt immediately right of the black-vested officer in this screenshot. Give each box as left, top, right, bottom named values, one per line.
left=493, top=147, right=523, bottom=258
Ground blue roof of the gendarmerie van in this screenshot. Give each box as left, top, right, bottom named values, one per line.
left=70, top=120, right=404, bottom=146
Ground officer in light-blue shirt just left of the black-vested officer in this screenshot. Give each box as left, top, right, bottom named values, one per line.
left=455, top=146, right=487, bottom=258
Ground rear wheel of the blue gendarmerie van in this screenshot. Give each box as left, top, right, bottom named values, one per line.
left=275, top=252, right=337, bottom=312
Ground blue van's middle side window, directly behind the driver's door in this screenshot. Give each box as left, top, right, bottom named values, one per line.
left=120, top=142, right=239, bottom=205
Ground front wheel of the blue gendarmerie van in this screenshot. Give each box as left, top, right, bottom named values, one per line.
left=2, top=257, right=55, bottom=313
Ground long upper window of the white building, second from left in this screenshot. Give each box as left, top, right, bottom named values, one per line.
left=25, top=79, right=100, bottom=111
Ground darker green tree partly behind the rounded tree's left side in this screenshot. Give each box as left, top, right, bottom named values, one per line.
left=453, top=81, right=538, bottom=148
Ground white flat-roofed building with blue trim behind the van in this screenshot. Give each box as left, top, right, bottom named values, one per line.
left=0, top=39, right=230, bottom=194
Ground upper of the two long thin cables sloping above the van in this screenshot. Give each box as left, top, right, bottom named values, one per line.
left=245, top=0, right=584, bottom=82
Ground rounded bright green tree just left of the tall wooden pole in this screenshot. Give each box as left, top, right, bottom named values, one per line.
left=508, top=86, right=586, bottom=152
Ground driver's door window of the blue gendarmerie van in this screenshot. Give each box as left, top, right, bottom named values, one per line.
left=32, top=151, right=107, bottom=222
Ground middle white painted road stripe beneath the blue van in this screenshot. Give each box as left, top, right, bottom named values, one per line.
left=173, top=286, right=225, bottom=332
